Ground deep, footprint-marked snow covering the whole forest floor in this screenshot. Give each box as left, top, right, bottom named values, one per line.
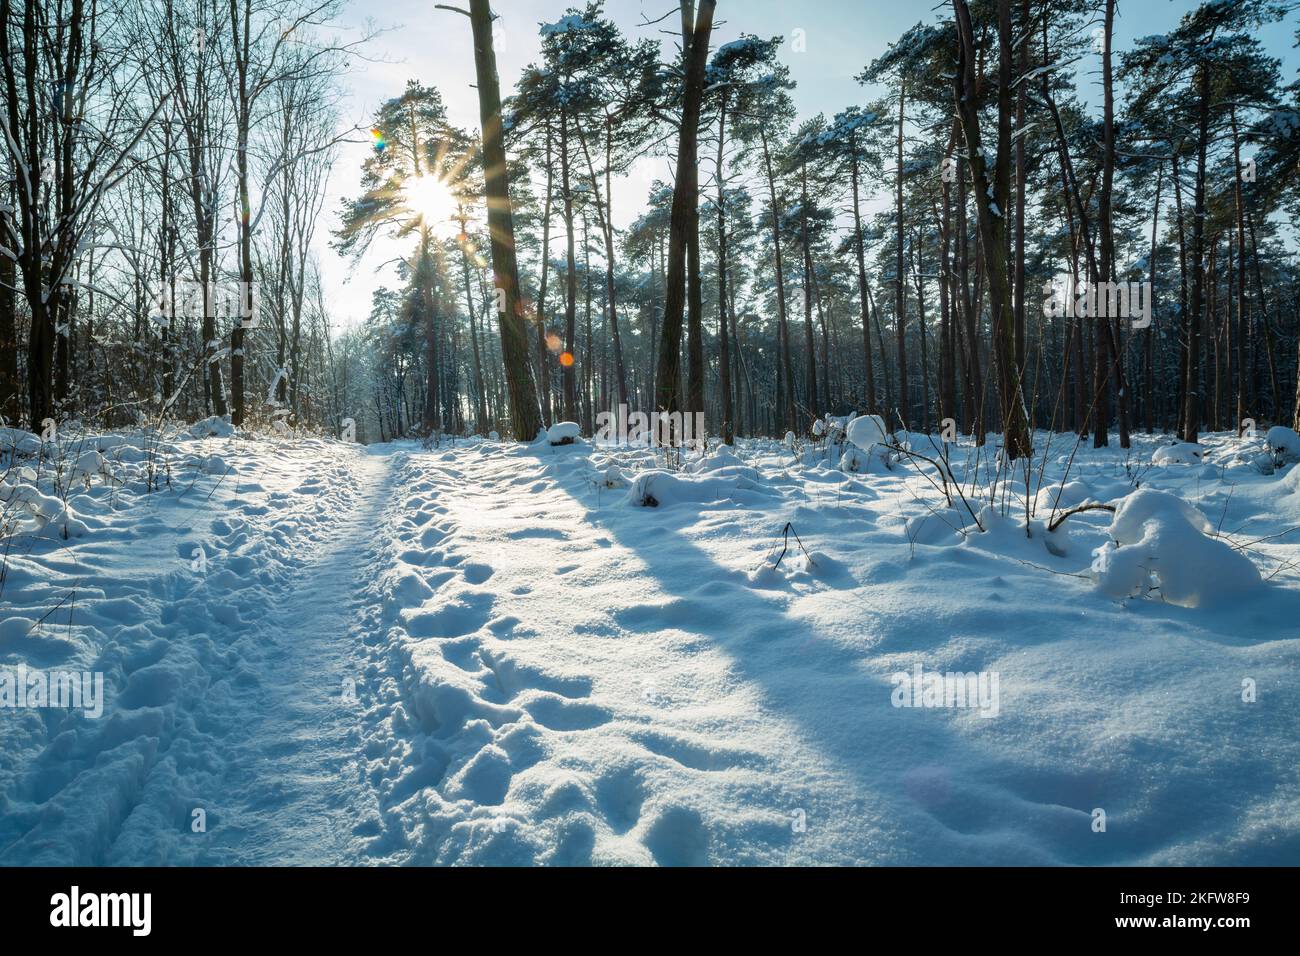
left=0, top=423, right=1300, bottom=865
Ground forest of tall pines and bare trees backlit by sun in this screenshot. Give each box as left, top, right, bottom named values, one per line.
left=0, top=0, right=1300, bottom=457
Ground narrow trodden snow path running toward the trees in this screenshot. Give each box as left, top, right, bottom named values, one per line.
left=163, top=454, right=391, bottom=865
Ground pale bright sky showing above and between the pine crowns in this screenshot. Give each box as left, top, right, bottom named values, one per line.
left=317, top=0, right=1300, bottom=325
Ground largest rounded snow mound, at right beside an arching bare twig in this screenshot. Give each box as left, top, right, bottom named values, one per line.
left=1092, top=488, right=1260, bottom=607
